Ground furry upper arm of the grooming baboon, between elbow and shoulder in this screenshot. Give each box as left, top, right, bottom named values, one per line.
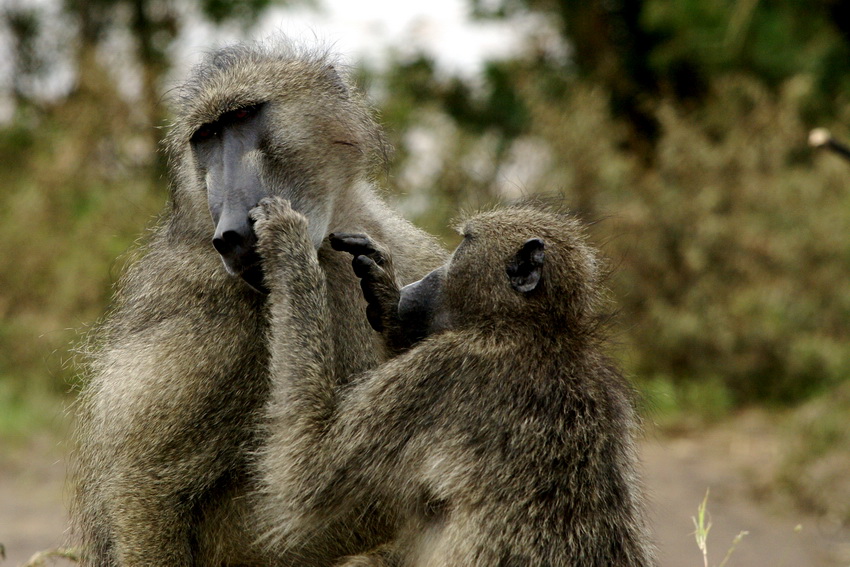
left=294, top=341, right=464, bottom=517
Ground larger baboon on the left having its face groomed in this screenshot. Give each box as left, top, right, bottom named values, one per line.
left=72, top=42, right=445, bottom=567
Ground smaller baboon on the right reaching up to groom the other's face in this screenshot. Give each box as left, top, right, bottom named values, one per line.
left=252, top=199, right=655, bottom=567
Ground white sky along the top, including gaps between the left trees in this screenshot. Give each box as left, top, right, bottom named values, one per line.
left=0, top=0, right=553, bottom=122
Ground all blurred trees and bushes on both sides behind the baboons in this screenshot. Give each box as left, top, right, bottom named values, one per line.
left=0, top=0, right=850, bottom=426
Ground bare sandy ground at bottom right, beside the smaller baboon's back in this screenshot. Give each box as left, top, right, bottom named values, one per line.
left=642, top=423, right=850, bottom=567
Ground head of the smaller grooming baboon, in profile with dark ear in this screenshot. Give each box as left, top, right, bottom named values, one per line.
left=398, top=205, right=600, bottom=338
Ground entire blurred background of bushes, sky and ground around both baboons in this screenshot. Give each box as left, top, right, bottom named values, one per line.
left=0, top=0, right=850, bottom=566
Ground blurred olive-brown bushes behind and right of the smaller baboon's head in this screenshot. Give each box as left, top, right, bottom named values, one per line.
left=380, top=63, right=850, bottom=406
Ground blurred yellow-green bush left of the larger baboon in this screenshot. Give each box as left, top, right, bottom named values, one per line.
left=0, top=65, right=165, bottom=399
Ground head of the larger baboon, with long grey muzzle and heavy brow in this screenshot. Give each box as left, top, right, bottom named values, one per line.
left=168, top=43, right=383, bottom=289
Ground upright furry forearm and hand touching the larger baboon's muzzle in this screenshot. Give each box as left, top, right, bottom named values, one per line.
left=252, top=198, right=380, bottom=546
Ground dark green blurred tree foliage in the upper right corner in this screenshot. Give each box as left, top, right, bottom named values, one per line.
left=471, top=0, right=850, bottom=158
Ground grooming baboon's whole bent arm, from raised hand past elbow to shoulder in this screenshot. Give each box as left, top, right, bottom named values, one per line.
left=252, top=198, right=445, bottom=544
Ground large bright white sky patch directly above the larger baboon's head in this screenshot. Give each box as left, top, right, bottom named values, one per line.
left=177, top=0, right=540, bottom=75
